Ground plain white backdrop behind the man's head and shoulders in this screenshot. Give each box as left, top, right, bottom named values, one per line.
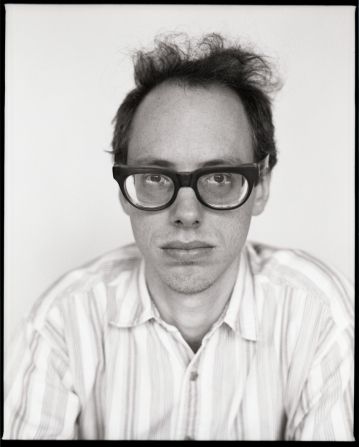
left=4, top=5, right=355, bottom=348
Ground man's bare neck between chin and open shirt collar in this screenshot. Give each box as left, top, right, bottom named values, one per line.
left=146, top=257, right=239, bottom=352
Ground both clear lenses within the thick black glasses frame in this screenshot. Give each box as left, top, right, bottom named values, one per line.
left=125, top=172, right=249, bottom=209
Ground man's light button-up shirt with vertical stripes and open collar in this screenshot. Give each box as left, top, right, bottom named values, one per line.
left=4, top=242, right=354, bottom=440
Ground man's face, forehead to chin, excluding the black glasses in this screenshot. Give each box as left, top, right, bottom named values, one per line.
left=121, top=83, right=268, bottom=294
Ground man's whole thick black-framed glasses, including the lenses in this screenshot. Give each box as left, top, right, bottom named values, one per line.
left=112, top=155, right=269, bottom=211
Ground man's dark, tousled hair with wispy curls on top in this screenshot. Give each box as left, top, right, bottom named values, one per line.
left=112, top=33, right=279, bottom=169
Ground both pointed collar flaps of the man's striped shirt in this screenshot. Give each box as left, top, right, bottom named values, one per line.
left=108, top=247, right=257, bottom=341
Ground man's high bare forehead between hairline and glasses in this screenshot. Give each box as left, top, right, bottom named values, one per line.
left=128, top=83, right=253, bottom=169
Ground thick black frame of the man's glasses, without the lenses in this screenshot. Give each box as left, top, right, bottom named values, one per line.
left=112, top=155, right=269, bottom=211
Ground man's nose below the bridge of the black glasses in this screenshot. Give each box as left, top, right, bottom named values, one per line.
left=171, top=187, right=203, bottom=228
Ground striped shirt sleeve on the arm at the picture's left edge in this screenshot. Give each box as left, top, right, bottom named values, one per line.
left=3, top=319, right=80, bottom=440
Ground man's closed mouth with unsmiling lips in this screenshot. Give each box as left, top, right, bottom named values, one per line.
left=161, top=241, right=214, bottom=263
